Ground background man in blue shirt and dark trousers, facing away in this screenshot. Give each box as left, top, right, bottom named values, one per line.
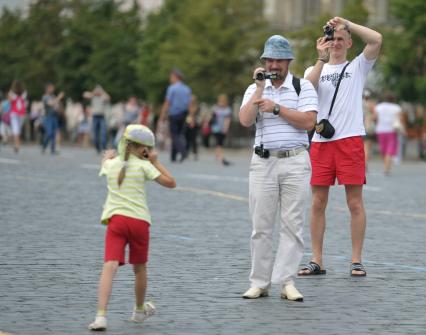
left=160, top=68, right=192, bottom=162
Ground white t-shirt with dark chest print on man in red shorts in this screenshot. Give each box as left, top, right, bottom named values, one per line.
left=312, top=53, right=375, bottom=142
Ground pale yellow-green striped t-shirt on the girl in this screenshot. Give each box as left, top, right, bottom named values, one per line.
left=99, top=155, right=161, bottom=224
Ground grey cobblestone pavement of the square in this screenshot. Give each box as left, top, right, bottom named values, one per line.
left=0, top=146, right=426, bottom=335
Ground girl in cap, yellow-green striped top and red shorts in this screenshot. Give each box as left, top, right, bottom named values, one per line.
left=89, top=125, right=176, bottom=330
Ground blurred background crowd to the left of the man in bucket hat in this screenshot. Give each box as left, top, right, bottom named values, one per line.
left=0, top=77, right=236, bottom=166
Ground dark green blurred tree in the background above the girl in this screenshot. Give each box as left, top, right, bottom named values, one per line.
left=58, top=0, right=143, bottom=101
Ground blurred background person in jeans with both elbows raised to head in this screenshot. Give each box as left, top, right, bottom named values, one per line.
left=83, top=85, right=111, bottom=153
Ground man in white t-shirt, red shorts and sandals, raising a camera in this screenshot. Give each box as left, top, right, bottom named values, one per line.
left=299, top=17, right=382, bottom=276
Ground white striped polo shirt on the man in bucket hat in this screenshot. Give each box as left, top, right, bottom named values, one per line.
left=241, top=73, right=318, bottom=150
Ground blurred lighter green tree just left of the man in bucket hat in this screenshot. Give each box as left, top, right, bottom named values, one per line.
left=137, top=0, right=266, bottom=102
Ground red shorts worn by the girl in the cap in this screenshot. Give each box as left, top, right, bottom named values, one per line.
left=104, top=215, right=149, bottom=265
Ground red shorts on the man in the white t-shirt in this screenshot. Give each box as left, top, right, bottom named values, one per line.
left=310, top=136, right=366, bottom=186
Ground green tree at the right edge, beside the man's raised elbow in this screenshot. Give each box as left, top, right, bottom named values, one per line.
left=383, top=0, right=426, bottom=104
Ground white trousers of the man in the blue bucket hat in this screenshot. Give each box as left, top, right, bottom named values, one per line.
left=249, top=151, right=311, bottom=288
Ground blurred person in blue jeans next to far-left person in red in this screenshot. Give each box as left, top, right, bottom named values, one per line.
left=42, top=83, right=64, bottom=155
